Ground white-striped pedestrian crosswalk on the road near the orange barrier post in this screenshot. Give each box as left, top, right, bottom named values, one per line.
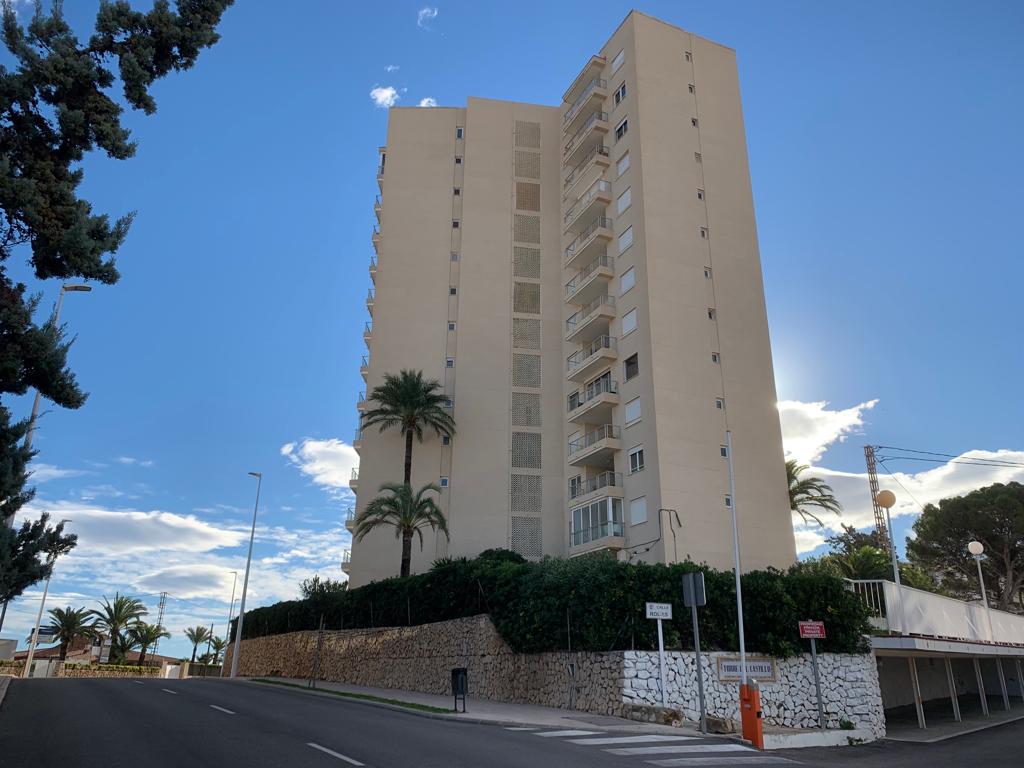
left=507, top=727, right=799, bottom=768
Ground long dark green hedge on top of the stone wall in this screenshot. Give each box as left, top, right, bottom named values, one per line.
left=232, top=557, right=870, bottom=657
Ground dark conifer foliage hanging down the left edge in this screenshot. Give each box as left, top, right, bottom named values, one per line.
left=0, top=0, right=232, bottom=597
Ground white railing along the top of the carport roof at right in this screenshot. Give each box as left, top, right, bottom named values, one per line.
left=849, top=580, right=1024, bottom=645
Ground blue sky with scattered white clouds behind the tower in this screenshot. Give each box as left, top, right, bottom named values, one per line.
left=4, top=0, right=1024, bottom=653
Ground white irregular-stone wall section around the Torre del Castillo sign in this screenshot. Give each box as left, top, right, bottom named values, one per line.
left=623, top=651, right=886, bottom=738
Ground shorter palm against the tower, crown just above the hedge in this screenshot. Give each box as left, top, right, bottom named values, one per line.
left=354, top=482, right=449, bottom=577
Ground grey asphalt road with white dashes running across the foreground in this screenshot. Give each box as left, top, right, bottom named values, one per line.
left=0, top=679, right=1024, bottom=768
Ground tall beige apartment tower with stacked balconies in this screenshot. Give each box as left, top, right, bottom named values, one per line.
left=344, top=11, right=795, bottom=586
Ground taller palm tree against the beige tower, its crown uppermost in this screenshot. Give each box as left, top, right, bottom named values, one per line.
left=362, top=371, right=455, bottom=485
